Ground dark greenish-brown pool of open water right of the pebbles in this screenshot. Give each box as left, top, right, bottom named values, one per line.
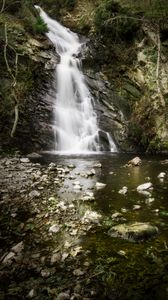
left=43, top=153, right=168, bottom=299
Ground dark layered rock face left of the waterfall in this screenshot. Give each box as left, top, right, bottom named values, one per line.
left=0, top=8, right=58, bottom=152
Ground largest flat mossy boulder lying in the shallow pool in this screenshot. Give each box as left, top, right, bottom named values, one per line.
left=108, top=222, right=158, bottom=242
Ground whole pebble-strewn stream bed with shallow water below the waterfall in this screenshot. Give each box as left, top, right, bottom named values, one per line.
left=0, top=153, right=168, bottom=300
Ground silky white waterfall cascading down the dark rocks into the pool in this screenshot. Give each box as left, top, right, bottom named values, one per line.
left=36, top=6, right=116, bottom=154
